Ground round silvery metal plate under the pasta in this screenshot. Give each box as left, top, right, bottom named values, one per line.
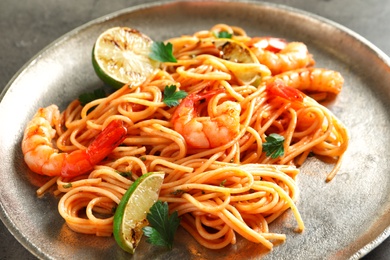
left=0, top=1, right=390, bottom=259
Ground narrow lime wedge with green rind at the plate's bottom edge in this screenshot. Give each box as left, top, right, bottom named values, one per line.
left=113, top=172, right=164, bottom=254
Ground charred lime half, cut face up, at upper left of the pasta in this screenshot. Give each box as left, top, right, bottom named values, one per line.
left=92, top=27, right=159, bottom=88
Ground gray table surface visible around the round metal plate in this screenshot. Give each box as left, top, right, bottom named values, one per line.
left=0, top=0, right=390, bottom=260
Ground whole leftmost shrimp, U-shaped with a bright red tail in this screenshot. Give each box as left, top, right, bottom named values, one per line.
left=22, top=105, right=127, bottom=177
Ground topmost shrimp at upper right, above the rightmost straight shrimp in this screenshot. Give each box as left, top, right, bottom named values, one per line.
left=248, top=37, right=315, bottom=75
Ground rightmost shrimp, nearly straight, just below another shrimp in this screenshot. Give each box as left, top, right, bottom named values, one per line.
left=267, top=68, right=344, bottom=94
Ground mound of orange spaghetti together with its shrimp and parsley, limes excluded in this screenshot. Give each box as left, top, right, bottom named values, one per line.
left=21, top=24, right=349, bottom=250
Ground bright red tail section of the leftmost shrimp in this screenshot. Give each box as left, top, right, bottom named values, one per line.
left=61, top=120, right=127, bottom=177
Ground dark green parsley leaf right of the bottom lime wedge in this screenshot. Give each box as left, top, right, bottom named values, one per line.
left=142, top=201, right=180, bottom=250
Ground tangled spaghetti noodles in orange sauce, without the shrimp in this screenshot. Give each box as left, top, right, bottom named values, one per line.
left=29, top=24, right=348, bottom=252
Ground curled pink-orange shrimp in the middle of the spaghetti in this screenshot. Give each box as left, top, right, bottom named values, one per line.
left=171, top=91, right=241, bottom=148
